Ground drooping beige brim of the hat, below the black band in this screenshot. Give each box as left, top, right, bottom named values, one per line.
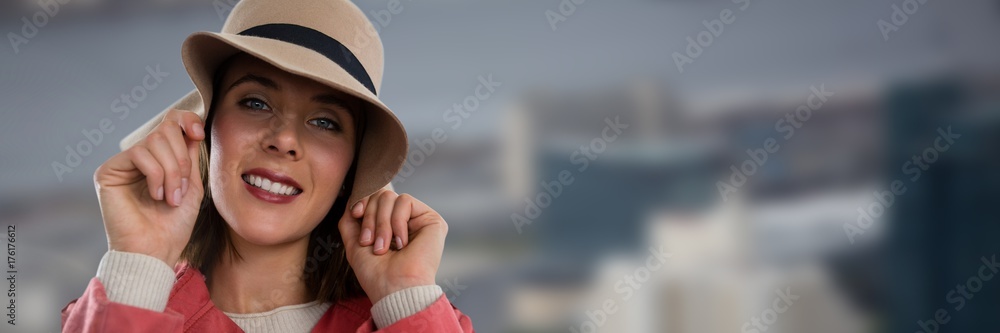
left=120, top=32, right=408, bottom=207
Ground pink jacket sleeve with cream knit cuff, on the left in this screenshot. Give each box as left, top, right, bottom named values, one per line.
left=62, top=251, right=184, bottom=333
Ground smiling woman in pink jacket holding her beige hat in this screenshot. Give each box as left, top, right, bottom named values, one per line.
left=62, top=0, right=473, bottom=332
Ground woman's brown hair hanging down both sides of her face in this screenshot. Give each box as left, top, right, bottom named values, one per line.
left=181, top=54, right=365, bottom=302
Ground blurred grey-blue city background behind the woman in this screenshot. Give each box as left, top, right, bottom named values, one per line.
left=0, top=0, right=1000, bottom=333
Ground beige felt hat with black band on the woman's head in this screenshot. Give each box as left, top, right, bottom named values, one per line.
left=120, top=0, right=407, bottom=207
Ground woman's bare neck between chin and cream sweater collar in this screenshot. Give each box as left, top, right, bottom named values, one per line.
left=208, top=230, right=314, bottom=313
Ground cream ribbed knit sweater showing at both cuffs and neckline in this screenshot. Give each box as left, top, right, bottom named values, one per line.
left=97, top=251, right=444, bottom=333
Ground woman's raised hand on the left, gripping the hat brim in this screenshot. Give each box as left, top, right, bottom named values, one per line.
left=94, top=110, right=205, bottom=267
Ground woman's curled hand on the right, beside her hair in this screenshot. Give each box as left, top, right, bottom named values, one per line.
left=339, top=189, right=448, bottom=304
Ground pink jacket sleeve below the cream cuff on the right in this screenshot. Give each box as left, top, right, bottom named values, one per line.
left=356, top=295, right=475, bottom=333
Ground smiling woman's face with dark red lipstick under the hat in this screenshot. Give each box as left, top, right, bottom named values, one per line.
left=208, top=54, right=359, bottom=245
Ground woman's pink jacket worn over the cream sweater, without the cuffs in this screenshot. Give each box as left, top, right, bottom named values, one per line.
left=62, top=265, right=475, bottom=333
